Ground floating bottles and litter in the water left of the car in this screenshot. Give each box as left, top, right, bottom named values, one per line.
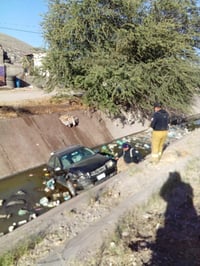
left=0, top=179, right=71, bottom=236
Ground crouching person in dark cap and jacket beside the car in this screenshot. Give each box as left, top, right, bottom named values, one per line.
left=122, top=143, right=143, bottom=164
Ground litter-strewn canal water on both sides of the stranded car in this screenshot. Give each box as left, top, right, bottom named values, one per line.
left=0, top=120, right=199, bottom=235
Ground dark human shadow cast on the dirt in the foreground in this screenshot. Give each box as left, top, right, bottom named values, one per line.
left=148, top=172, right=200, bottom=266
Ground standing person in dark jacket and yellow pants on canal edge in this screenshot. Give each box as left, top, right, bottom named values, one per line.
left=150, top=102, right=169, bottom=163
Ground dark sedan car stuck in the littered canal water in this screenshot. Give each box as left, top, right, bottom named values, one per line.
left=44, top=145, right=117, bottom=194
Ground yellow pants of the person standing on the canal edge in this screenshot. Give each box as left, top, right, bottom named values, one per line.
left=151, top=130, right=168, bottom=162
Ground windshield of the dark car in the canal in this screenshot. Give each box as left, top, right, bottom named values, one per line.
left=60, top=147, right=95, bottom=169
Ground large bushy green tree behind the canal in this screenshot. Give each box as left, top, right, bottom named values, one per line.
left=43, top=0, right=200, bottom=116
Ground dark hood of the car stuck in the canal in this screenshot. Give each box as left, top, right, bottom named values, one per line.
left=70, top=154, right=110, bottom=173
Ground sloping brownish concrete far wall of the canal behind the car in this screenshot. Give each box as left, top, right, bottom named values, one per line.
left=0, top=111, right=145, bottom=179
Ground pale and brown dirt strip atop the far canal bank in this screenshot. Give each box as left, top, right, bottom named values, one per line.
left=0, top=88, right=85, bottom=119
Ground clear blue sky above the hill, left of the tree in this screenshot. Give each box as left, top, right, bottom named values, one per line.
left=0, top=0, right=48, bottom=48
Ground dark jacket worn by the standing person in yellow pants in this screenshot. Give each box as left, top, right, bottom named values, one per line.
left=151, top=109, right=169, bottom=130
